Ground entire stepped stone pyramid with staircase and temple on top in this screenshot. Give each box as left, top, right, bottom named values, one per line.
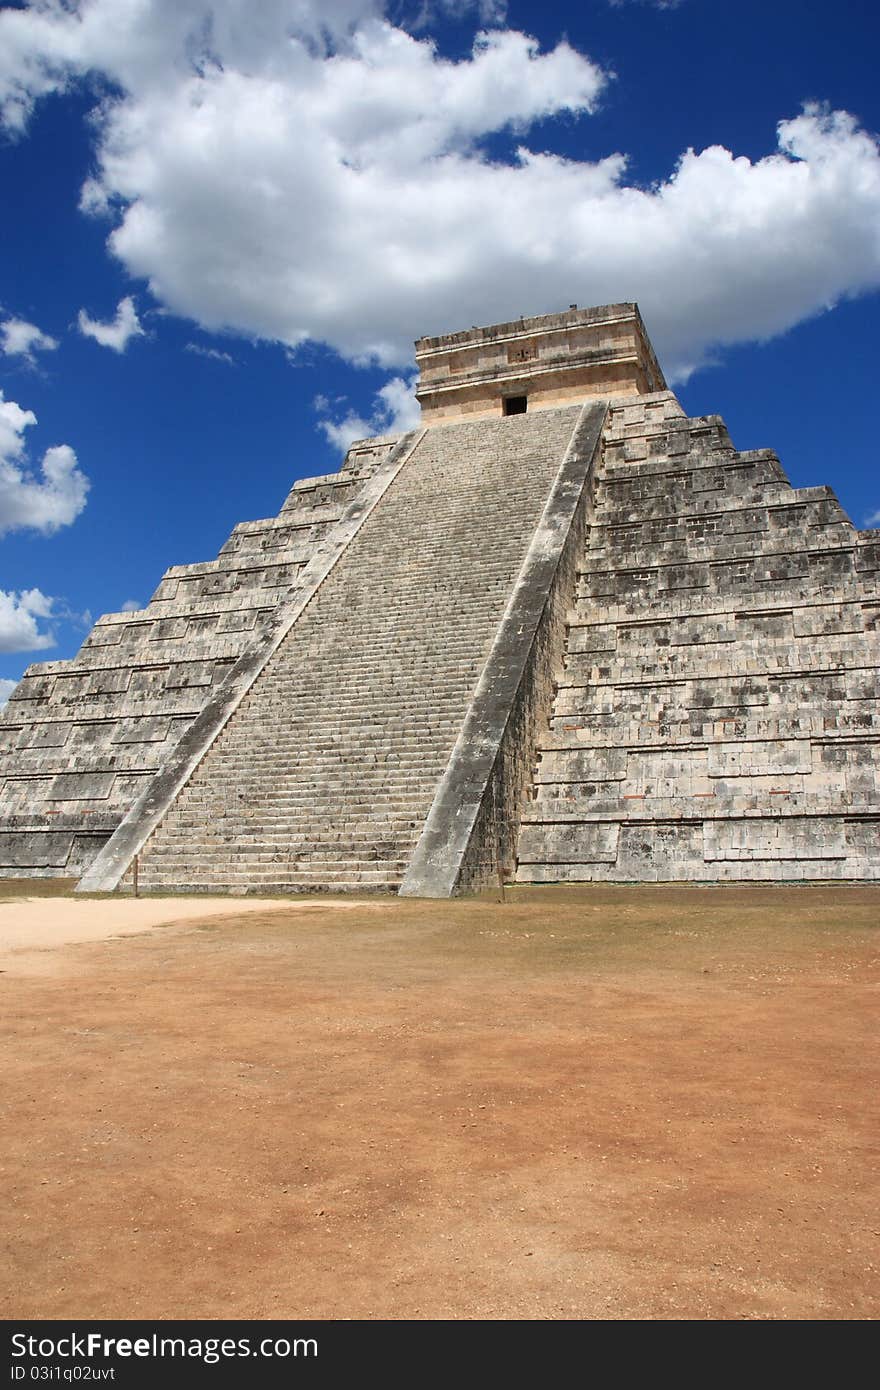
left=0, top=304, right=880, bottom=897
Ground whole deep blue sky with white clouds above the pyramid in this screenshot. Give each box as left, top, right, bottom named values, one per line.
left=0, top=0, right=880, bottom=692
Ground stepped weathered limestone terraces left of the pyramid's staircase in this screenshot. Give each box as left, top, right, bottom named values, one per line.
left=0, top=439, right=393, bottom=877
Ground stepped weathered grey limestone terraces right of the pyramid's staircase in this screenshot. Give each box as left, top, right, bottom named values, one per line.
left=517, top=393, right=880, bottom=881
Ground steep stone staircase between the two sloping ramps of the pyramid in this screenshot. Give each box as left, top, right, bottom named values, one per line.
left=129, top=406, right=580, bottom=892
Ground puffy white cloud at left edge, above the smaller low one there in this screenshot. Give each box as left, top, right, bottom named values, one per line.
left=0, top=391, right=89, bottom=539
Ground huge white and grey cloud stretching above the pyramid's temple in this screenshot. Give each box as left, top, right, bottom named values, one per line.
left=0, top=0, right=880, bottom=379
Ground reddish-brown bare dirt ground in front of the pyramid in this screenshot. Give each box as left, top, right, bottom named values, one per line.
left=0, top=887, right=880, bottom=1319
